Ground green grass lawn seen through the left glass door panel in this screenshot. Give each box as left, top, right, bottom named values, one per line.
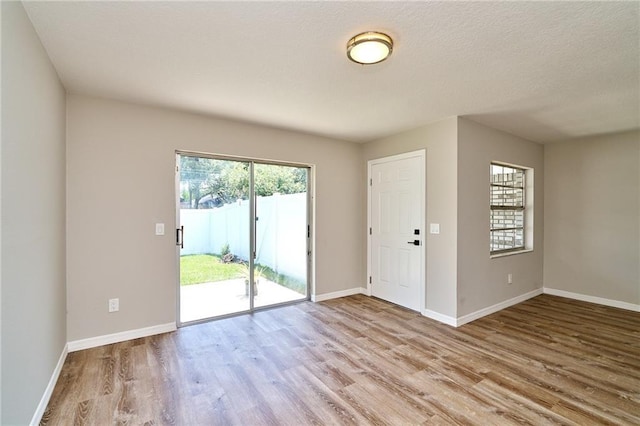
left=180, top=254, right=247, bottom=285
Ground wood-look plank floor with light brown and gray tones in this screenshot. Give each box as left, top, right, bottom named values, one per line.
left=41, top=295, right=640, bottom=425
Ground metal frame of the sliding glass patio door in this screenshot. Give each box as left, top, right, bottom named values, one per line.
left=173, top=149, right=315, bottom=328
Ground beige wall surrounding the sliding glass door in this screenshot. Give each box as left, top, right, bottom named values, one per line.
left=67, top=95, right=365, bottom=341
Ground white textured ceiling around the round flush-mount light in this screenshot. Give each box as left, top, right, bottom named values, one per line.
left=25, top=1, right=640, bottom=143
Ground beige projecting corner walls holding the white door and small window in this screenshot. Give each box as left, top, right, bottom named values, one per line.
left=363, top=117, right=544, bottom=318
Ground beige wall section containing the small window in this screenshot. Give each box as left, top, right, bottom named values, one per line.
left=458, top=118, right=544, bottom=317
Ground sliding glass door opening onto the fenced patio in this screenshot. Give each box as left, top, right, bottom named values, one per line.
left=176, top=153, right=310, bottom=324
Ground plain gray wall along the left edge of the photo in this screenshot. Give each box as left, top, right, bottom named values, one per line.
left=0, top=2, right=67, bottom=424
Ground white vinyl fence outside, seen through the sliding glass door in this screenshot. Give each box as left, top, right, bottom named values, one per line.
left=180, top=193, right=307, bottom=280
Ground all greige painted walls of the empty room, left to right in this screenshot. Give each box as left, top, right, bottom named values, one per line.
left=0, top=2, right=640, bottom=424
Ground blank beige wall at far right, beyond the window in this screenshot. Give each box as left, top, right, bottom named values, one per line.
left=544, top=130, right=640, bottom=305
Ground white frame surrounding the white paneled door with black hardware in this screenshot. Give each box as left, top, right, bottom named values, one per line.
left=366, top=149, right=428, bottom=314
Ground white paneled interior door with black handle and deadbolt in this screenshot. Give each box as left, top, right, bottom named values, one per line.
left=369, top=151, right=425, bottom=311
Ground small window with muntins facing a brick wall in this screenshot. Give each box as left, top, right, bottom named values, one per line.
left=489, top=163, right=526, bottom=255
